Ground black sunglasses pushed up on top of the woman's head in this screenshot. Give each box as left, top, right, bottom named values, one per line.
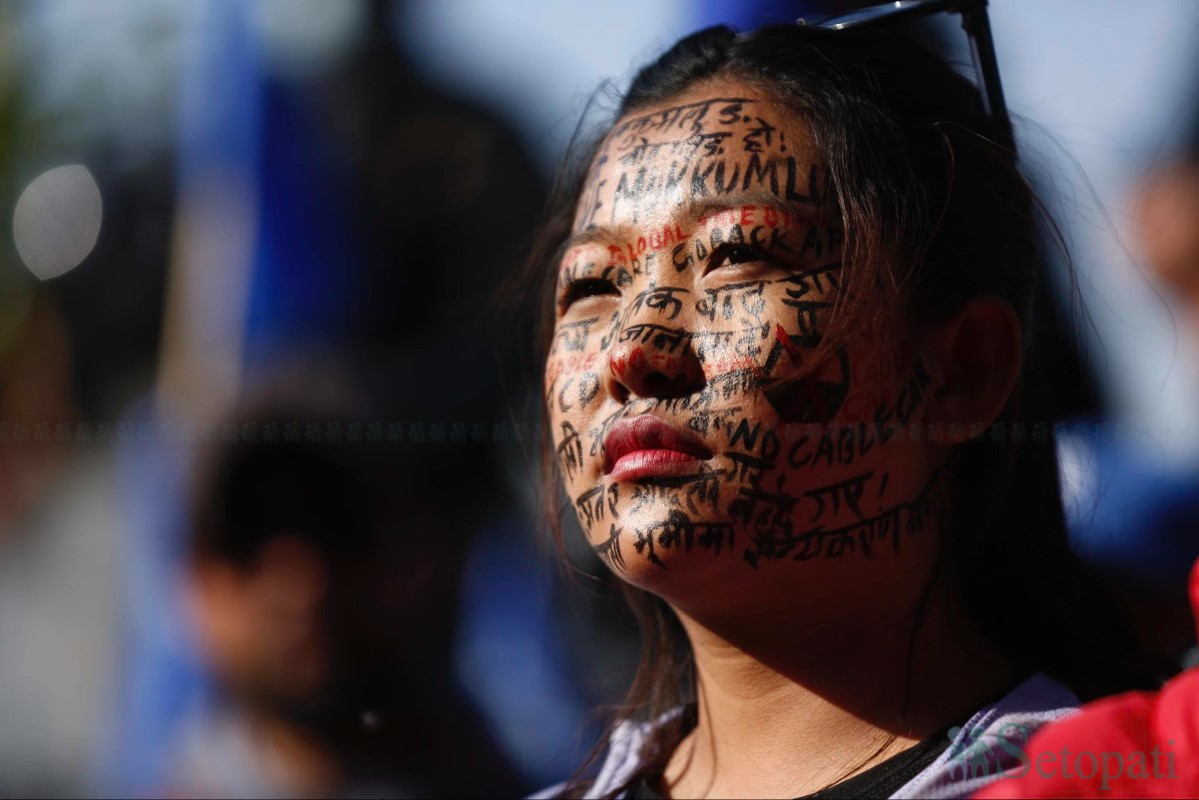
left=795, top=0, right=1016, bottom=152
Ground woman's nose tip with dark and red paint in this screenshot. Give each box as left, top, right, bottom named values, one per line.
left=607, top=318, right=704, bottom=403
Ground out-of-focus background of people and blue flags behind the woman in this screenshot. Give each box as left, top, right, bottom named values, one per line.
left=0, top=0, right=1199, bottom=796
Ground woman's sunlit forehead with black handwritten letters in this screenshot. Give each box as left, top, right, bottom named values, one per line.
left=574, top=82, right=827, bottom=231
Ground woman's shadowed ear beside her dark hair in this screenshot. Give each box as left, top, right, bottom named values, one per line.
left=922, top=295, right=1022, bottom=444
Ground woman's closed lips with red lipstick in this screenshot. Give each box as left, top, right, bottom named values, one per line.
left=604, top=414, right=712, bottom=481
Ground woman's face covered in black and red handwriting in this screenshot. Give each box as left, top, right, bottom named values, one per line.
left=544, top=82, right=940, bottom=607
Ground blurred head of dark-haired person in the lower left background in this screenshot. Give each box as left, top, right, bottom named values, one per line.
left=192, top=431, right=417, bottom=727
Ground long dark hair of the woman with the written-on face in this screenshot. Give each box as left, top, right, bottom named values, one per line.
left=520, top=25, right=1164, bottom=792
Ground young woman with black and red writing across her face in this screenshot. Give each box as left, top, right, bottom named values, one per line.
left=531, top=26, right=1151, bottom=798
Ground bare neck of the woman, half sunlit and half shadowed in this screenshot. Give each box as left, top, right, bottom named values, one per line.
left=664, top=582, right=1012, bottom=798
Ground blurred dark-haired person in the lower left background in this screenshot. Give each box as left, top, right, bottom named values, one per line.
left=162, top=360, right=520, bottom=798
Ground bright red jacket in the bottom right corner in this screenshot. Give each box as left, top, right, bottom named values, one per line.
left=976, top=563, right=1199, bottom=800
